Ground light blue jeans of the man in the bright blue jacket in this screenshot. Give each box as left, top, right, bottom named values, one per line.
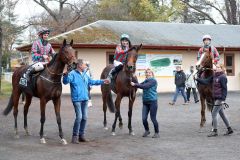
left=73, top=101, right=88, bottom=136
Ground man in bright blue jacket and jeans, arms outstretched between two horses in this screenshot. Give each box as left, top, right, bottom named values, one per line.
left=63, top=59, right=109, bottom=143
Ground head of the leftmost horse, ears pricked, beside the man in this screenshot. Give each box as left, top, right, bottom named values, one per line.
left=59, top=39, right=76, bottom=66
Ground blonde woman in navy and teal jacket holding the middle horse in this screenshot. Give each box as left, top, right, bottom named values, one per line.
left=131, top=69, right=160, bottom=138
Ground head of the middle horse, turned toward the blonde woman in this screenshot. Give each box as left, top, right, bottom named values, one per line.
left=125, top=44, right=142, bottom=72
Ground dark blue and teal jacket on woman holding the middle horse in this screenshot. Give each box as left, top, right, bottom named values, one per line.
left=135, top=78, right=157, bottom=102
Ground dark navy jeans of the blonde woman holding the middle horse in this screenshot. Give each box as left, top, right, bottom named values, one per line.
left=142, top=100, right=159, bottom=133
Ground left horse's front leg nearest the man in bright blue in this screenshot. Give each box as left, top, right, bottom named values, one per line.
left=53, top=97, right=67, bottom=145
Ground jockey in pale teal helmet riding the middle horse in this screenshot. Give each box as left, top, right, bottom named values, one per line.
left=108, top=34, right=132, bottom=81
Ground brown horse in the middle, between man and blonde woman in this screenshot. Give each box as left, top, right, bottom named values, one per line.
left=101, top=45, right=142, bottom=135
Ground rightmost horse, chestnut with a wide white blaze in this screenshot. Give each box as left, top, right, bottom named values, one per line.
left=196, top=49, right=214, bottom=128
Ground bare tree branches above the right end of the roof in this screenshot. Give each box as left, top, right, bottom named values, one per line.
left=180, top=0, right=240, bottom=25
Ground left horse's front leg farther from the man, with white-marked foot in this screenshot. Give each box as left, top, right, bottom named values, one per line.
left=39, top=98, right=46, bottom=144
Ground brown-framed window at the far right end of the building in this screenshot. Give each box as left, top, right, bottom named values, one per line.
left=224, top=54, right=235, bottom=76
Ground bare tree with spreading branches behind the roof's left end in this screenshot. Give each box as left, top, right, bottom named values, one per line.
left=32, top=0, right=96, bottom=33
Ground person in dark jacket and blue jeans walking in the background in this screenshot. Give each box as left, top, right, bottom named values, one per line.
left=169, top=66, right=188, bottom=105
